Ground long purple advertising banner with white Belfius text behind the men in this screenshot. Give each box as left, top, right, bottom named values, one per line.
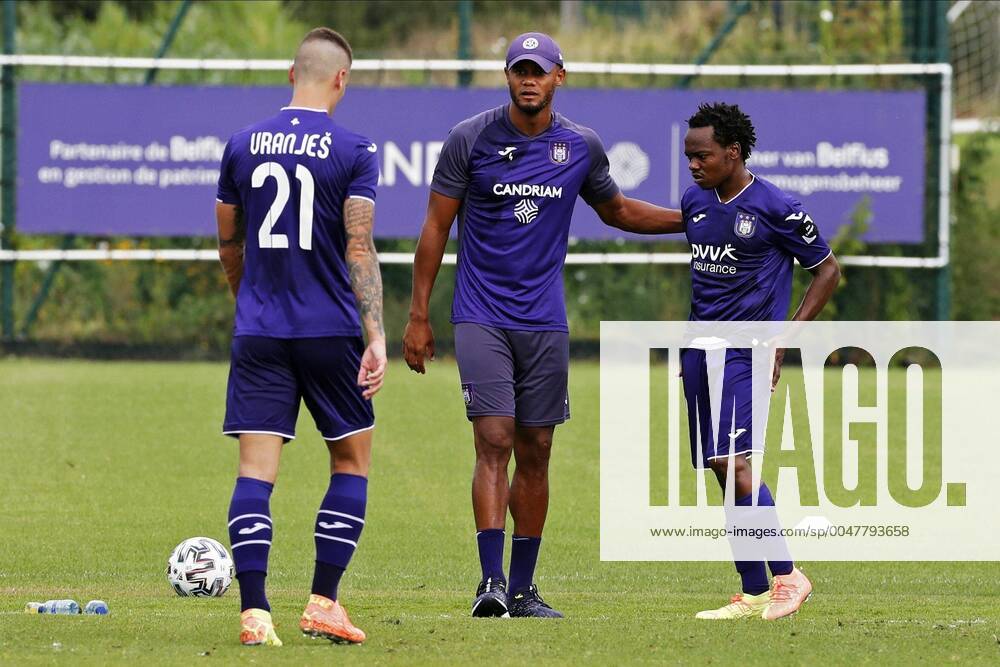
left=17, top=83, right=925, bottom=243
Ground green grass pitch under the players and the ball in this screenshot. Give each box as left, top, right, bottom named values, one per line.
left=0, top=360, right=1000, bottom=665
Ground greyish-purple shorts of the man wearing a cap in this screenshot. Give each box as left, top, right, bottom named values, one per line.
left=455, top=322, right=569, bottom=426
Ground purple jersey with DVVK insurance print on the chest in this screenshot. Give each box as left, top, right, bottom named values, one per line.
left=681, top=176, right=830, bottom=321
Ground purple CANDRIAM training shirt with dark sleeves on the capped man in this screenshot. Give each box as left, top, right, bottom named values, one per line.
left=431, top=105, right=618, bottom=331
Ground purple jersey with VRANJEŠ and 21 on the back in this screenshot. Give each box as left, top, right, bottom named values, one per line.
left=217, top=107, right=378, bottom=338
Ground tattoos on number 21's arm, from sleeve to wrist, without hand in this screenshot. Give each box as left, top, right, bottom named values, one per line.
left=344, top=198, right=385, bottom=338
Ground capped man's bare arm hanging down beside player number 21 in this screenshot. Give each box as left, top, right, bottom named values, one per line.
left=403, top=191, right=462, bottom=373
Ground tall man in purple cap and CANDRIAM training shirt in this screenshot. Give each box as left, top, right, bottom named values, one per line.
left=403, top=33, right=682, bottom=617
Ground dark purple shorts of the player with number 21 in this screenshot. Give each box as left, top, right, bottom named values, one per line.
left=222, top=336, right=375, bottom=442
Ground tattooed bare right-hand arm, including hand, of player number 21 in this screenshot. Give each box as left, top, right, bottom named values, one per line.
left=344, top=197, right=387, bottom=399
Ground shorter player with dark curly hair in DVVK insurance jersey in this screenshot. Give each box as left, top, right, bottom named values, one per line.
left=681, top=103, right=840, bottom=620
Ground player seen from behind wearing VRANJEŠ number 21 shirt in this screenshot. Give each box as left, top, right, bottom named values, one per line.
left=216, top=28, right=386, bottom=646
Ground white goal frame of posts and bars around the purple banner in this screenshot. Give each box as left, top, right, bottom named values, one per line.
left=0, top=55, right=952, bottom=269
